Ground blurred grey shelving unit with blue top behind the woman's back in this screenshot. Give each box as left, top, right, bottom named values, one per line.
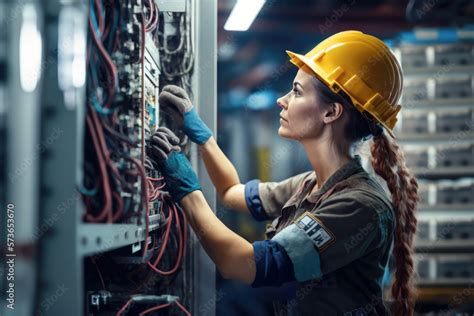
left=393, top=29, right=474, bottom=311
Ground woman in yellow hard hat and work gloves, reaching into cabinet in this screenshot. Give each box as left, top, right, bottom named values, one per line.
left=150, top=31, right=418, bottom=315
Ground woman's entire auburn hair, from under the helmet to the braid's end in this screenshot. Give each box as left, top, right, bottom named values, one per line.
left=314, top=77, right=419, bottom=316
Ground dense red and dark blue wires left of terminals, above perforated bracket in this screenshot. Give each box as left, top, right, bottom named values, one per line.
left=79, top=0, right=148, bottom=223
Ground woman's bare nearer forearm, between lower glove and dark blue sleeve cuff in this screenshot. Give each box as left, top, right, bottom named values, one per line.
left=180, top=191, right=256, bottom=284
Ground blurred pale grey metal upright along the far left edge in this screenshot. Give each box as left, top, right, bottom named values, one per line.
left=0, top=0, right=44, bottom=315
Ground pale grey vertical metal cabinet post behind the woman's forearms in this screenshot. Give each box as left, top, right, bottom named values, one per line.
left=192, top=0, right=217, bottom=316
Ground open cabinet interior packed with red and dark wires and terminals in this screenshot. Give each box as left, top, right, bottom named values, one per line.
left=80, top=0, right=192, bottom=315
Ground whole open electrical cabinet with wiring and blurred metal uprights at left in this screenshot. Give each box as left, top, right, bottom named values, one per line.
left=0, top=0, right=217, bottom=316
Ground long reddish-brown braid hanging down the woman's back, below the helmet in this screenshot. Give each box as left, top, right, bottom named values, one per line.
left=371, top=133, right=419, bottom=316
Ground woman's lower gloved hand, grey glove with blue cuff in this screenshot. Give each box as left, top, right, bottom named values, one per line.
left=147, top=127, right=201, bottom=202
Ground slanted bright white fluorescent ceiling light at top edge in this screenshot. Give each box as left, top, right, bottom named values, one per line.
left=224, top=0, right=265, bottom=31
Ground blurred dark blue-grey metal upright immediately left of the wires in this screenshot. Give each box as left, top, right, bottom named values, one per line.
left=36, top=0, right=87, bottom=315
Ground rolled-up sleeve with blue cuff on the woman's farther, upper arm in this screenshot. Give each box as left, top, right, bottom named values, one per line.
left=245, top=171, right=314, bottom=221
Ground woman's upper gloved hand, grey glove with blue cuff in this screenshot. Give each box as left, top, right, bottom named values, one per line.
left=158, top=85, right=212, bottom=145
